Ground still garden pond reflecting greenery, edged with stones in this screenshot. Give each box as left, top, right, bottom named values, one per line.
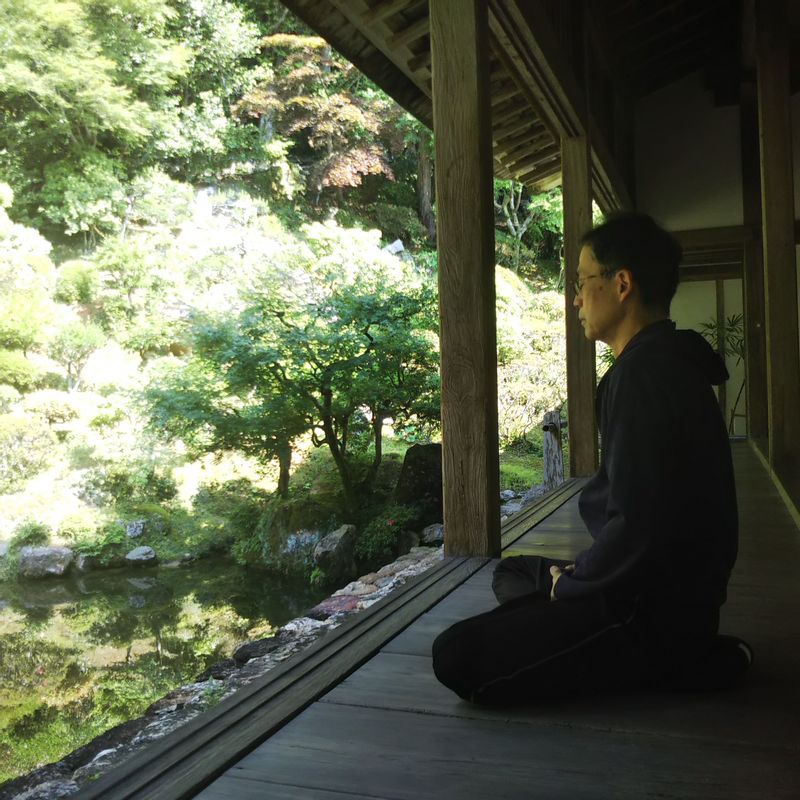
left=0, top=560, right=324, bottom=783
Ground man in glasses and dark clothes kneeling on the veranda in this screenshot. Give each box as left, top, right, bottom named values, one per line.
left=433, top=213, right=752, bottom=703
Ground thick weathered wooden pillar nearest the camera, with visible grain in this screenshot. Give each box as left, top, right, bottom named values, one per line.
left=430, top=0, right=500, bottom=557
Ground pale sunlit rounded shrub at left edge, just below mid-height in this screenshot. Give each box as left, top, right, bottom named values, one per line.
left=0, top=414, right=56, bottom=492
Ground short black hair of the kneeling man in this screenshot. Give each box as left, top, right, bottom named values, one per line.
left=581, top=211, right=683, bottom=314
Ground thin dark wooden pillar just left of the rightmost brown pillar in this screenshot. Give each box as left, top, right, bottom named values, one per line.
left=739, top=81, right=769, bottom=450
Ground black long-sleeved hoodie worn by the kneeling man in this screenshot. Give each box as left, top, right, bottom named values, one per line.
left=555, top=320, right=738, bottom=620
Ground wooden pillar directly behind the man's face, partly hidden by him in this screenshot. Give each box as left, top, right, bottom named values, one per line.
left=561, top=136, right=597, bottom=478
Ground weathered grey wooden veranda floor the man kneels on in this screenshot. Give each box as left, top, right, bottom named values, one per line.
left=78, top=442, right=800, bottom=800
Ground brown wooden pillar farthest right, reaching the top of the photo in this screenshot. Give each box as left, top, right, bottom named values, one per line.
left=756, top=0, right=800, bottom=477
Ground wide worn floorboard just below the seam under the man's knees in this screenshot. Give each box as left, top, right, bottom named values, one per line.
left=199, top=703, right=797, bottom=800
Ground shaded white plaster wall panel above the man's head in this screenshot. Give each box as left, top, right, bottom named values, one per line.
left=635, top=73, right=748, bottom=231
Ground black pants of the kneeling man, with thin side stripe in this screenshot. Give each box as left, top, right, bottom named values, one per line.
left=433, top=556, right=646, bottom=704
